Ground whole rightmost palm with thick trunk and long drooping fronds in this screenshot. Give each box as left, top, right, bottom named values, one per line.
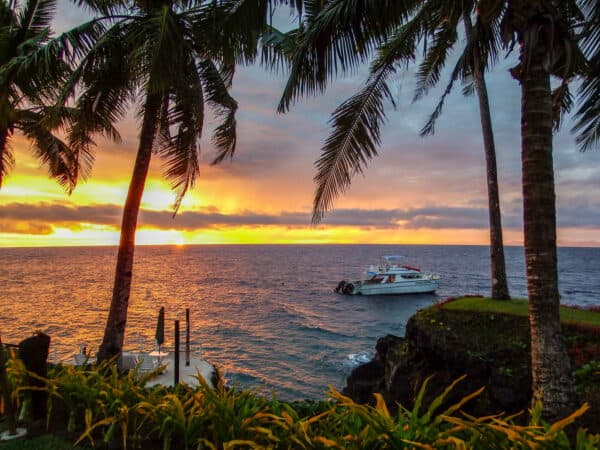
left=279, top=0, right=593, bottom=417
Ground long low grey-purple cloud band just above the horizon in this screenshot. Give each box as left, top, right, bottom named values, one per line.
left=0, top=200, right=600, bottom=234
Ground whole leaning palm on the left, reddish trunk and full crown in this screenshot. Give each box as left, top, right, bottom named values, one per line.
left=63, top=0, right=295, bottom=360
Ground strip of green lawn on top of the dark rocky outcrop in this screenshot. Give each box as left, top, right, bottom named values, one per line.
left=444, top=297, right=600, bottom=327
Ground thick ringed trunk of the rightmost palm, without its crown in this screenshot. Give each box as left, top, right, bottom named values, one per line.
left=518, top=34, right=575, bottom=419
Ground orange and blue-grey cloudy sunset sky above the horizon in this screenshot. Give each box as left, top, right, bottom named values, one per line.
left=0, top=0, right=600, bottom=247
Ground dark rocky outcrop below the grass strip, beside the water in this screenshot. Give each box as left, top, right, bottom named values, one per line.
left=343, top=305, right=600, bottom=432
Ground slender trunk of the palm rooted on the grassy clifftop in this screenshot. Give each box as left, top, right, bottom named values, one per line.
left=463, top=13, right=510, bottom=300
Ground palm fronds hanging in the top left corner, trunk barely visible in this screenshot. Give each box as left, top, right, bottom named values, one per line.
left=0, top=0, right=98, bottom=192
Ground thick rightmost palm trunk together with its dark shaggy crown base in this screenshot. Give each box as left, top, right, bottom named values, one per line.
left=502, top=0, right=583, bottom=418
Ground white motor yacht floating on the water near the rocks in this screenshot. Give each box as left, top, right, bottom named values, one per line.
left=334, top=255, right=440, bottom=295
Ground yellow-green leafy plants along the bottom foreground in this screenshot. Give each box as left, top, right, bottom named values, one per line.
left=8, top=364, right=600, bottom=450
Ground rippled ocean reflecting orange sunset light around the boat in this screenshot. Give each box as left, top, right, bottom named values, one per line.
left=0, top=245, right=600, bottom=400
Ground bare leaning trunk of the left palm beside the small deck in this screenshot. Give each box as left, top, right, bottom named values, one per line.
left=98, top=94, right=160, bottom=361
